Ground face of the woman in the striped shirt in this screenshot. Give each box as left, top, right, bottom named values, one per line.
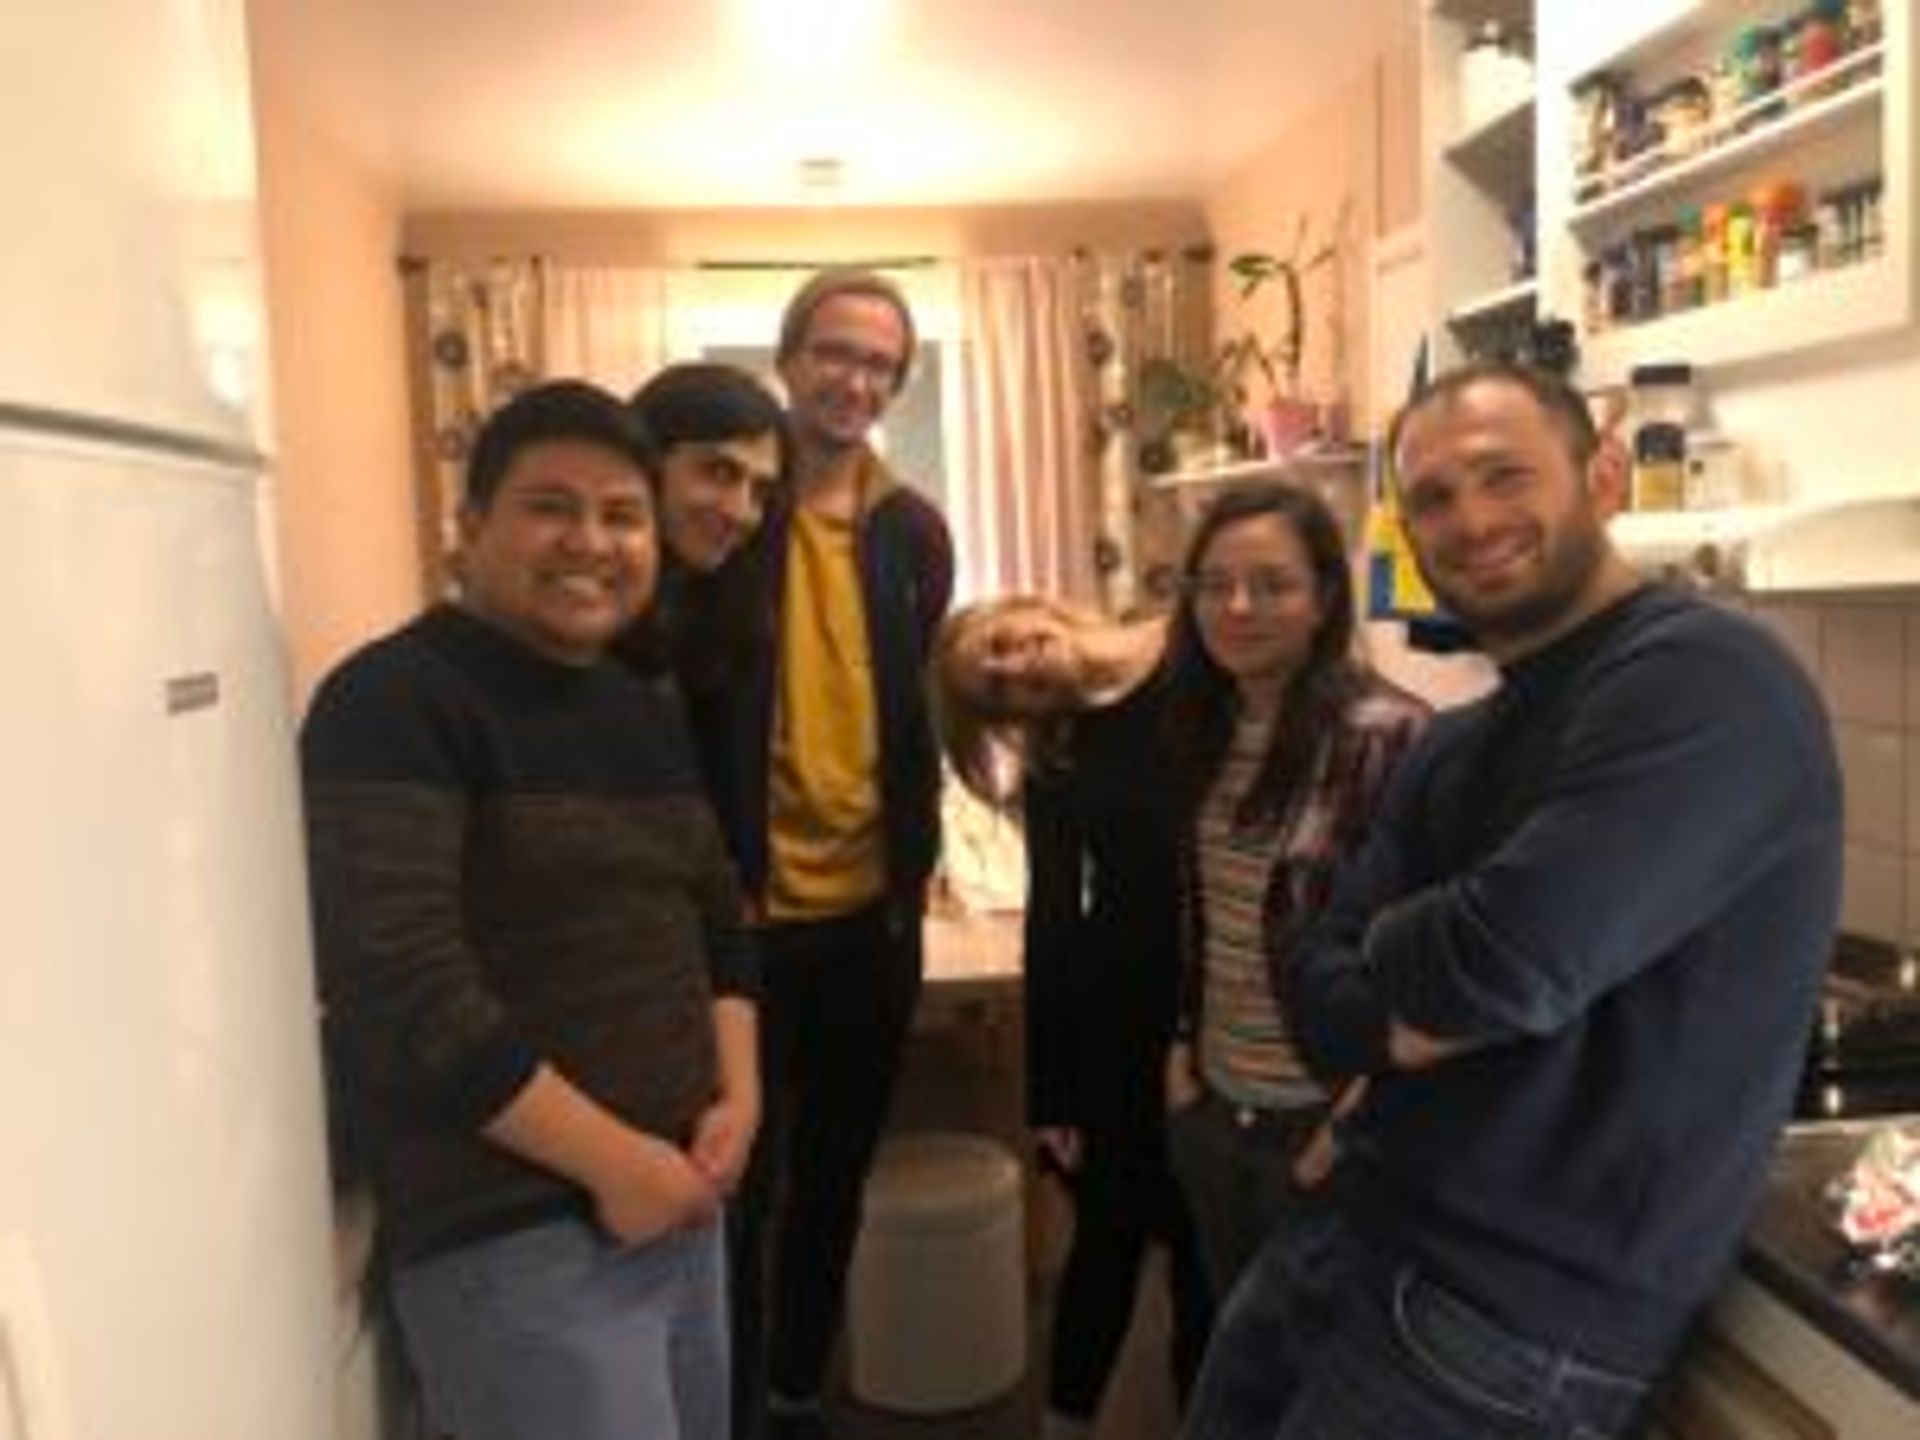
left=1188, top=513, right=1327, bottom=689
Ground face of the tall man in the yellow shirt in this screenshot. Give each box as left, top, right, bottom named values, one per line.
left=780, top=294, right=908, bottom=449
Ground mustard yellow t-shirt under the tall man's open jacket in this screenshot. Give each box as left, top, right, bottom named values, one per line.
left=766, top=505, right=887, bottom=920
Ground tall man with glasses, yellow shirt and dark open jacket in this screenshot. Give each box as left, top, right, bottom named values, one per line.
left=730, top=269, right=952, bottom=1440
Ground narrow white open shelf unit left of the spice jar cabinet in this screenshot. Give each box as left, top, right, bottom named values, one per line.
left=1421, top=0, right=1536, bottom=365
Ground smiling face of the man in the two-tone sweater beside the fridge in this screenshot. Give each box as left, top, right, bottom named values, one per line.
left=461, top=440, right=659, bottom=664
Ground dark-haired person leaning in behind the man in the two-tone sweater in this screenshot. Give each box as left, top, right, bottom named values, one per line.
left=618, top=361, right=793, bottom=698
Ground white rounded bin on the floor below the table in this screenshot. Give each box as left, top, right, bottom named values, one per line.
left=847, top=1135, right=1027, bottom=1415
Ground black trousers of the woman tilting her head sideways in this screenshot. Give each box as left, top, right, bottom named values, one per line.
left=1046, top=1123, right=1212, bottom=1419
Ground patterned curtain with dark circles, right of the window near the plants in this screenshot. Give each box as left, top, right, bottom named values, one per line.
left=1075, top=248, right=1213, bottom=614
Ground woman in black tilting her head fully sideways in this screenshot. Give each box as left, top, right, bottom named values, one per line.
left=931, top=595, right=1210, bottom=1440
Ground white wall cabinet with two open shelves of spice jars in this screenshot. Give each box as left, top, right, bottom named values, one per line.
left=1536, top=0, right=1920, bottom=388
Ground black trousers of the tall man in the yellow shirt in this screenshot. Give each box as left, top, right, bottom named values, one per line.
left=730, top=904, right=922, bottom=1440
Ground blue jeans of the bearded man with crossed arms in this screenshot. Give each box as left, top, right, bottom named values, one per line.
left=1185, top=1223, right=1647, bottom=1440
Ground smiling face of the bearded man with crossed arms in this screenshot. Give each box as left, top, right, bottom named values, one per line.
left=1398, top=378, right=1619, bottom=659
